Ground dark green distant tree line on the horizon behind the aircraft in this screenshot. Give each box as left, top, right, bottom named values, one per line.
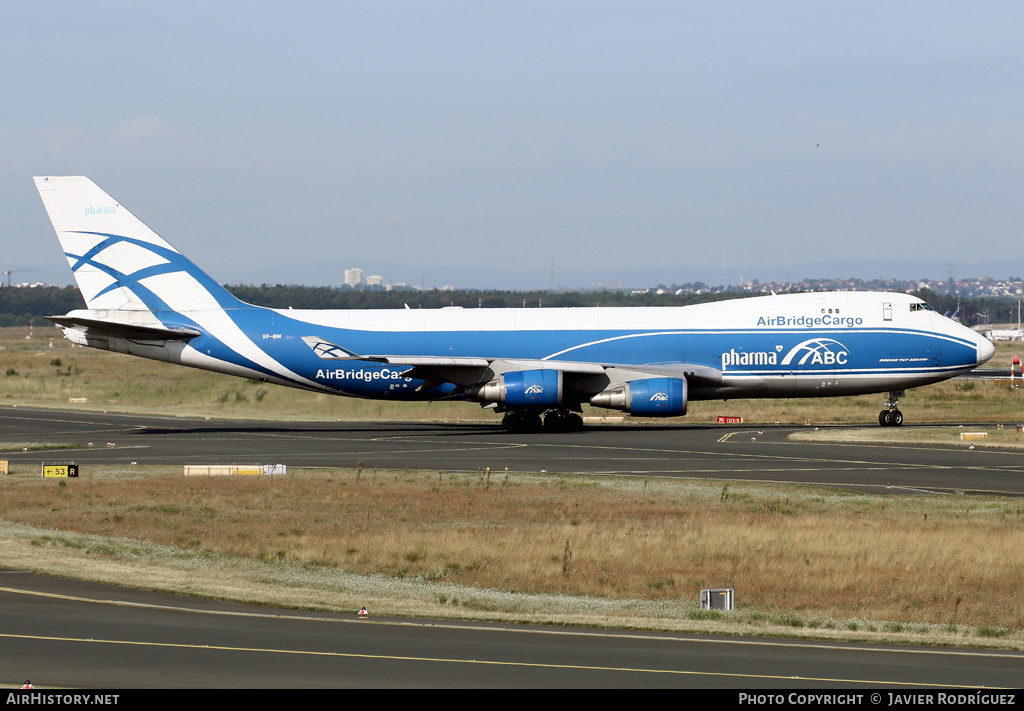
left=0, top=284, right=1017, bottom=327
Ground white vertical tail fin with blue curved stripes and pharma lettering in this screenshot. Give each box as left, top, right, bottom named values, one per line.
left=35, top=176, right=246, bottom=313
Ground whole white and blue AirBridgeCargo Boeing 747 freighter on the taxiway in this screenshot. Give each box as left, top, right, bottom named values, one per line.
left=36, top=177, right=993, bottom=431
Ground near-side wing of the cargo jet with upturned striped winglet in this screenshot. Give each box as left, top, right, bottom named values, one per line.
left=302, top=336, right=722, bottom=387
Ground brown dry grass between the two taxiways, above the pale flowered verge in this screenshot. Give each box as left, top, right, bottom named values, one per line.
left=0, top=468, right=1024, bottom=631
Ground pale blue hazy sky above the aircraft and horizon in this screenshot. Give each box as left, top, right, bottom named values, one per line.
left=6, top=0, right=1024, bottom=287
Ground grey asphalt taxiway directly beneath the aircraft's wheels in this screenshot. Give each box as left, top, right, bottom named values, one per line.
left=0, top=407, right=1024, bottom=496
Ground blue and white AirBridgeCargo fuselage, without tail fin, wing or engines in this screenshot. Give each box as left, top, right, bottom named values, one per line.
left=64, top=292, right=993, bottom=400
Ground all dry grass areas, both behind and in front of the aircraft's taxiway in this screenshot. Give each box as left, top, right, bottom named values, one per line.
left=0, top=329, right=1024, bottom=649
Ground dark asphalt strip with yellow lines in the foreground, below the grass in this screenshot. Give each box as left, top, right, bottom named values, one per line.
left=0, top=571, right=1024, bottom=693
